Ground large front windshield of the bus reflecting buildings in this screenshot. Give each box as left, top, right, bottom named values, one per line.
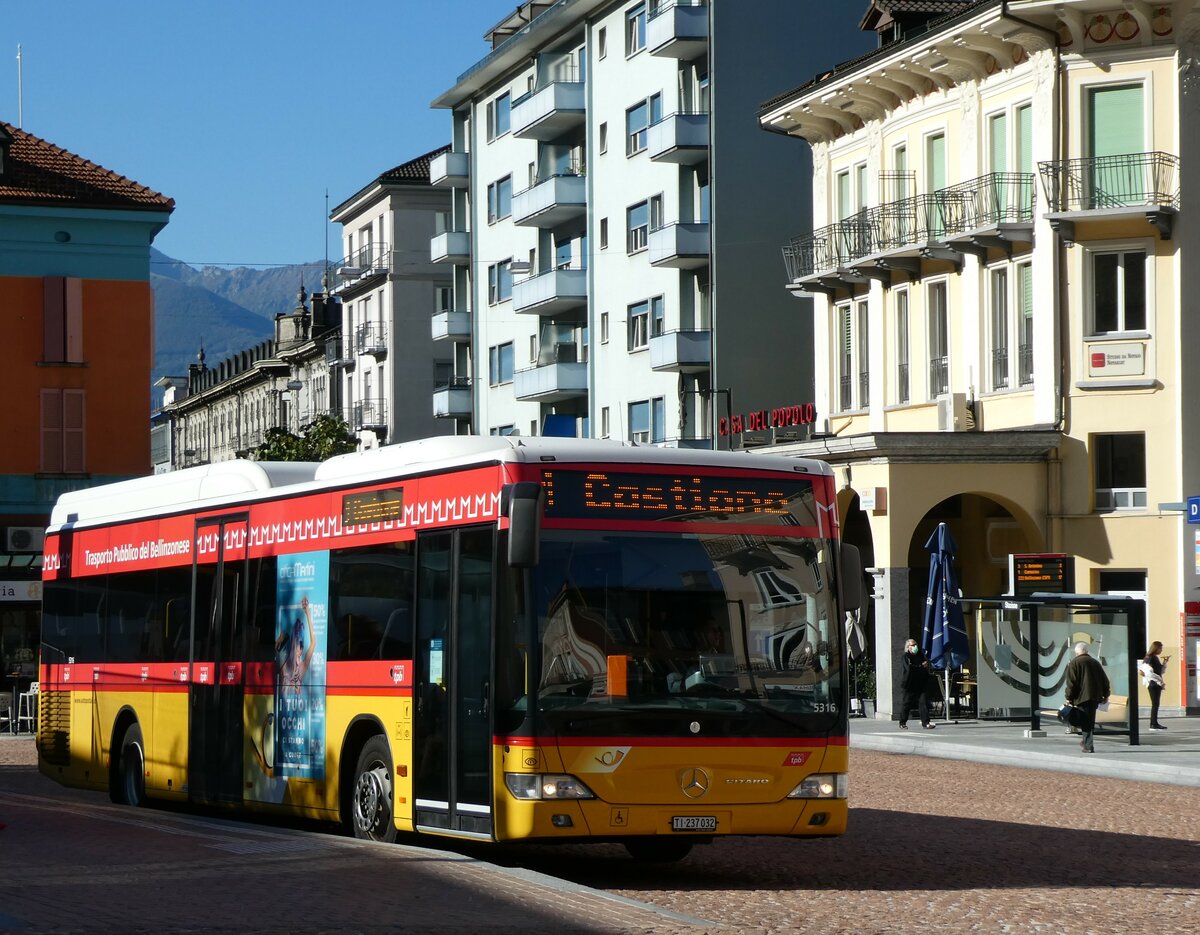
left=532, top=531, right=842, bottom=735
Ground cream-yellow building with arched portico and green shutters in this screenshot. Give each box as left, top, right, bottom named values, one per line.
left=758, top=0, right=1200, bottom=712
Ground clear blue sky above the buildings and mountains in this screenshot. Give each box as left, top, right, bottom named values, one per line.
left=0, top=0, right=517, bottom=265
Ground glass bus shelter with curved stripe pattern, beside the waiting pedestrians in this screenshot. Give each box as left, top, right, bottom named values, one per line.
left=961, top=594, right=1146, bottom=744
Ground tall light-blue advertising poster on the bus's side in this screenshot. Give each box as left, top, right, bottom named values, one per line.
left=275, top=552, right=329, bottom=779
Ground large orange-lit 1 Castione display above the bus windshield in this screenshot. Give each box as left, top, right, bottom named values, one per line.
left=542, top=471, right=812, bottom=523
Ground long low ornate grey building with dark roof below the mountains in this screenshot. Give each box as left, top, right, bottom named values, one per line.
left=155, top=287, right=345, bottom=471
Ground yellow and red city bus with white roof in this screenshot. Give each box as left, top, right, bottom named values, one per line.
left=37, top=437, right=862, bottom=859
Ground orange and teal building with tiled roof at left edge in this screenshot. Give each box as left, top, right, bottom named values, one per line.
left=0, top=121, right=175, bottom=695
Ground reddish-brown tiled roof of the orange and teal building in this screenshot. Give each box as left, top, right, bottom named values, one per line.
left=0, top=121, right=175, bottom=211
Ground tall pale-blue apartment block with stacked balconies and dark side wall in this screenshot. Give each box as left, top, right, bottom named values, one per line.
left=430, top=0, right=868, bottom=446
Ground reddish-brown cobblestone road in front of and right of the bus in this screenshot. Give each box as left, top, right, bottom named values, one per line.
left=0, top=742, right=1200, bottom=934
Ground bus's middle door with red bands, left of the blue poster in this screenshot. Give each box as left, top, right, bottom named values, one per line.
left=187, top=514, right=248, bottom=803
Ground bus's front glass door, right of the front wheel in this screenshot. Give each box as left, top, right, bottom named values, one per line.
left=414, top=527, right=496, bottom=839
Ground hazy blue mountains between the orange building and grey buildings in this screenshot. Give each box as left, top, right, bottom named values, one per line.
left=150, top=250, right=325, bottom=404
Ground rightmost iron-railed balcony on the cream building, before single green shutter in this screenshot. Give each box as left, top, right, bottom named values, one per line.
left=1038, top=152, right=1180, bottom=240
